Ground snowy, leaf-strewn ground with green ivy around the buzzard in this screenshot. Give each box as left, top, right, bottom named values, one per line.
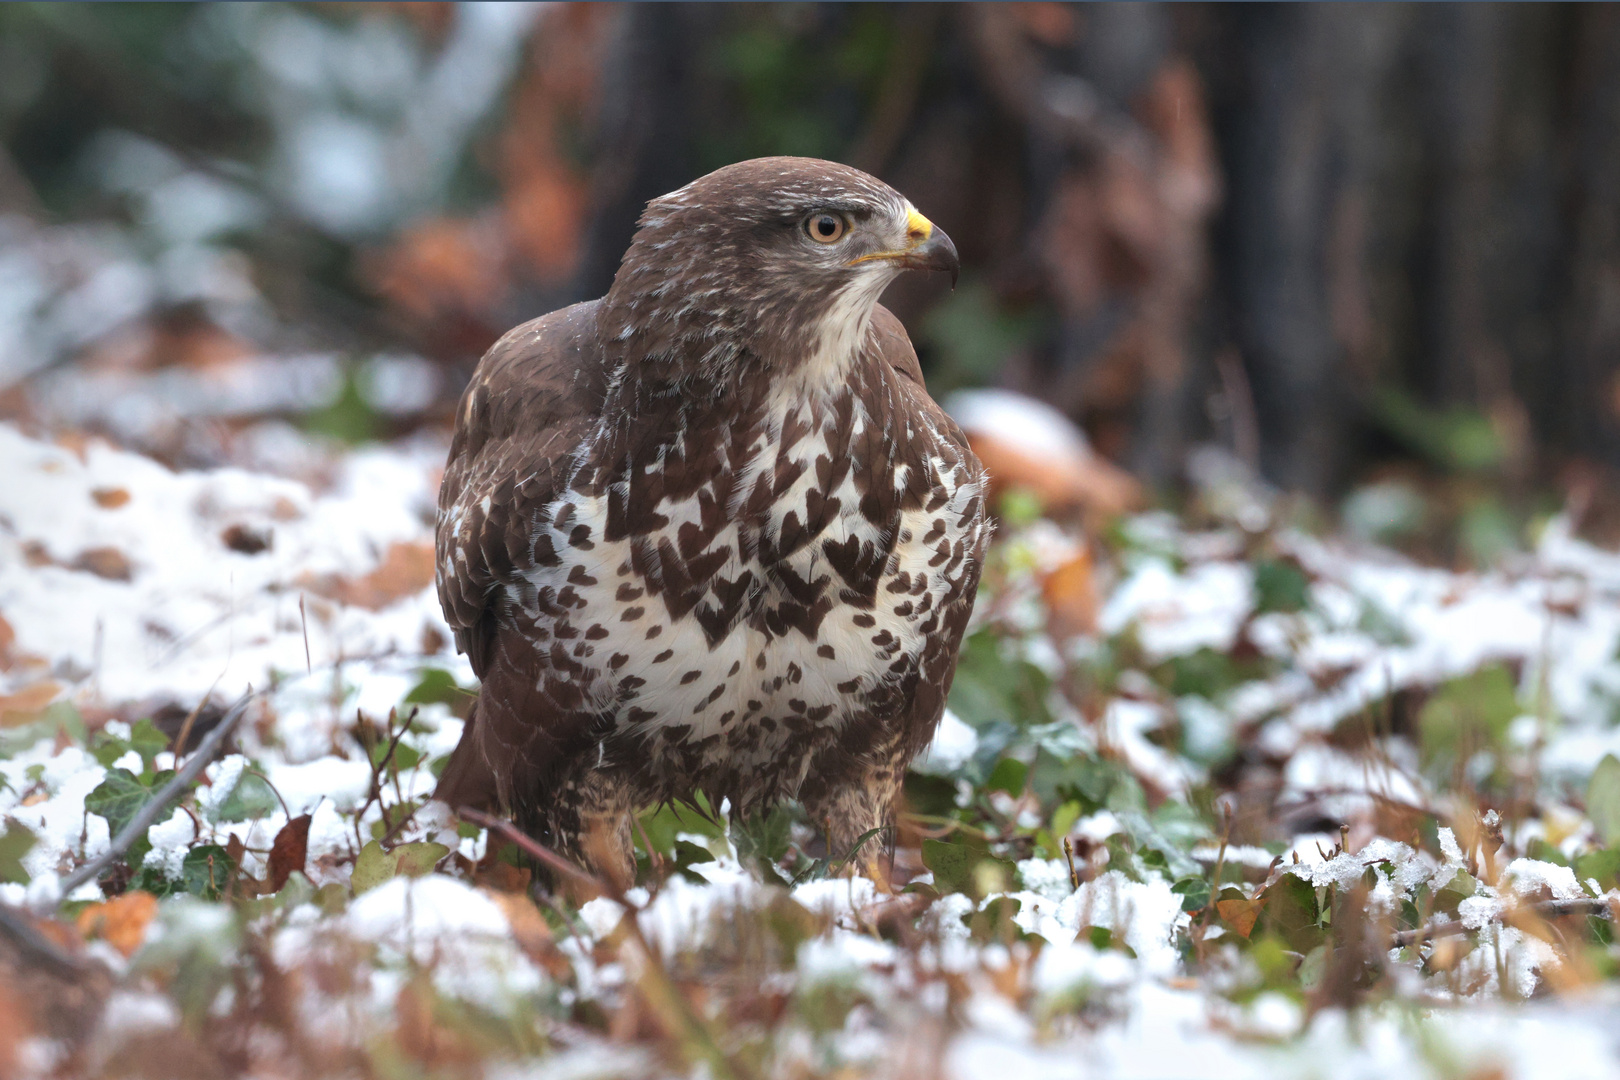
left=0, top=426, right=1620, bottom=1080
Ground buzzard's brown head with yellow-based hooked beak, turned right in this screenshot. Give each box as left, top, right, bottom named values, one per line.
left=601, top=157, right=961, bottom=382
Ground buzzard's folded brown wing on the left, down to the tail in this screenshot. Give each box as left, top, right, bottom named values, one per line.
left=436, top=301, right=606, bottom=806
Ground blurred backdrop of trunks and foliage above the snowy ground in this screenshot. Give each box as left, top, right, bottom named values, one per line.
left=0, top=3, right=1620, bottom=563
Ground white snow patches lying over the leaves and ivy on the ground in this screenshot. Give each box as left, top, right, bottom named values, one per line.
left=0, top=426, right=1620, bottom=1080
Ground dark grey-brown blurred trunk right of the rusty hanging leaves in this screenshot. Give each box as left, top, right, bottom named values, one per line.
left=1184, top=5, right=1620, bottom=494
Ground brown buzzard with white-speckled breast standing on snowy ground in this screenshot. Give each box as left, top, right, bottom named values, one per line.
left=437, top=157, right=990, bottom=881
